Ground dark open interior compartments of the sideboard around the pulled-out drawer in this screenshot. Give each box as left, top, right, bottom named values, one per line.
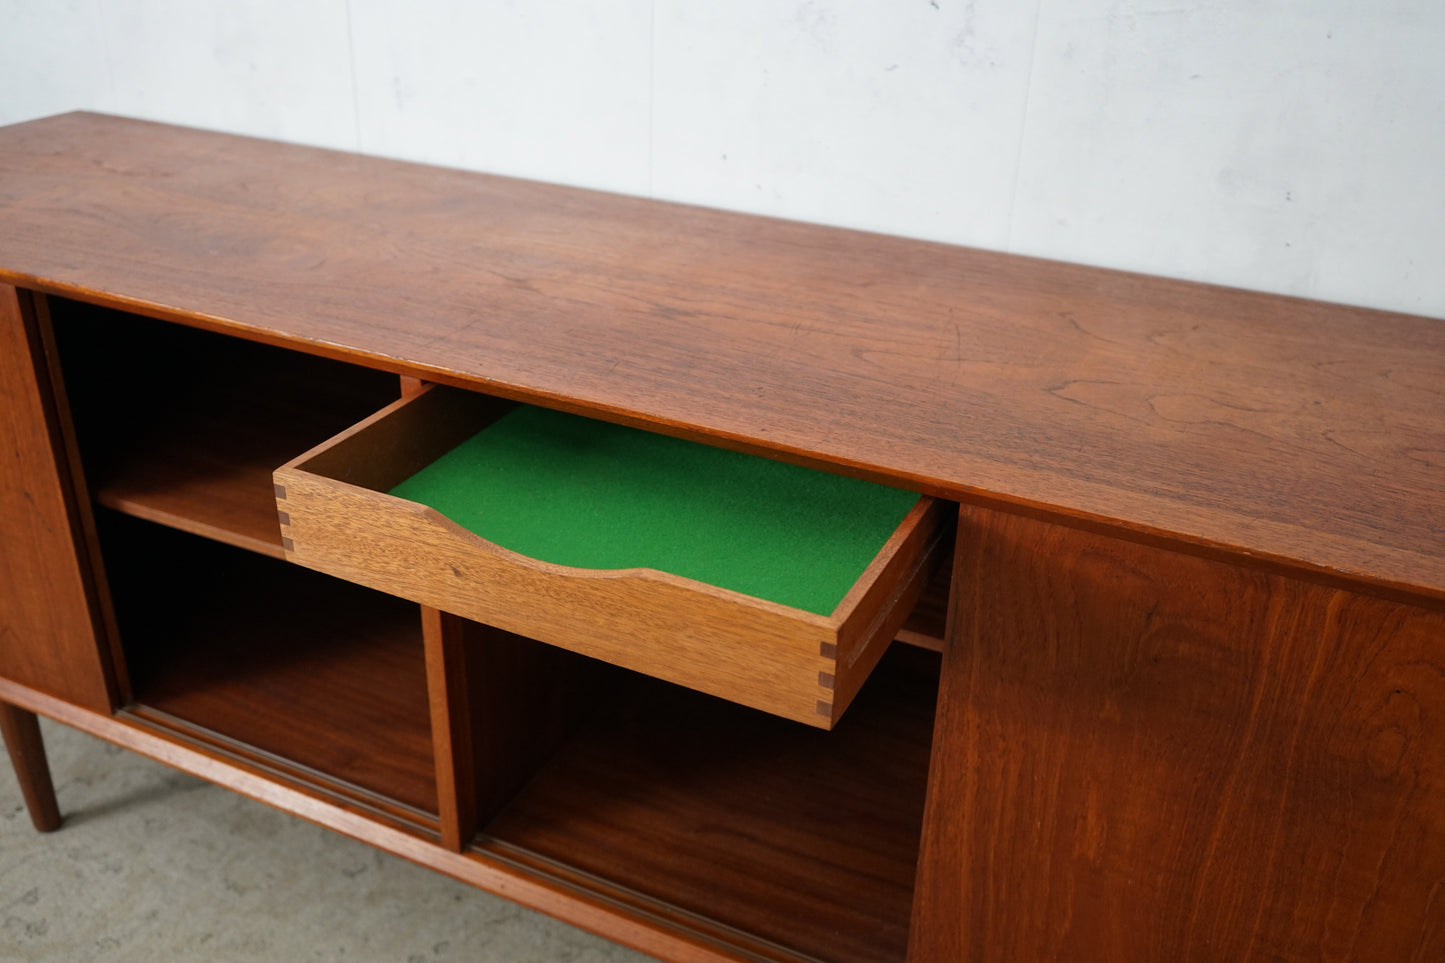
left=49, top=298, right=948, bottom=960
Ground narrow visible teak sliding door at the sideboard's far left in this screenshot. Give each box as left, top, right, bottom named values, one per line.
left=0, top=281, right=113, bottom=713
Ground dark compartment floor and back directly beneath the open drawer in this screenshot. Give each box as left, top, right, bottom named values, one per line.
left=477, top=645, right=938, bottom=962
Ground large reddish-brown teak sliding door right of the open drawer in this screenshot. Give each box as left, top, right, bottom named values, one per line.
left=912, top=509, right=1445, bottom=963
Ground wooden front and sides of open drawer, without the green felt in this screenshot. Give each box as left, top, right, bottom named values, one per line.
left=275, top=389, right=944, bottom=727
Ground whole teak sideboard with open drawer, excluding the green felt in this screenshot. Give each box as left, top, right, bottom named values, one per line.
left=0, top=114, right=1445, bottom=962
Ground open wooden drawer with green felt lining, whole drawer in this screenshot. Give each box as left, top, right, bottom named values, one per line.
left=275, top=388, right=948, bottom=727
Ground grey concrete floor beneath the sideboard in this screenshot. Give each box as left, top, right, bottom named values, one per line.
left=0, top=720, right=650, bottom=963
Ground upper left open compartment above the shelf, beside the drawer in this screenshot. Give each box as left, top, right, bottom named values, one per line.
left=51, top=298, right=399, bottom=558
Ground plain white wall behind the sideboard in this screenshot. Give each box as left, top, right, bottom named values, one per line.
left=0, top=0, right=1445, bottom=317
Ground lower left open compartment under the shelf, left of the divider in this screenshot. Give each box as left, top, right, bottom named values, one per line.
left=100, top=515, right=436, bottom=816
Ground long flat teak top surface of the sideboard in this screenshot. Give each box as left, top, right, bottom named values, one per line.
left=0, top=114, right=1445, bottom=599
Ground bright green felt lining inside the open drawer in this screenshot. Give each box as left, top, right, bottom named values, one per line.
left=390, top=406, right=918, bottom=616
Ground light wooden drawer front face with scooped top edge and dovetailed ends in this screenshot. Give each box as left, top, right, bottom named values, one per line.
left=276, top=468, right=837, bottom=726
